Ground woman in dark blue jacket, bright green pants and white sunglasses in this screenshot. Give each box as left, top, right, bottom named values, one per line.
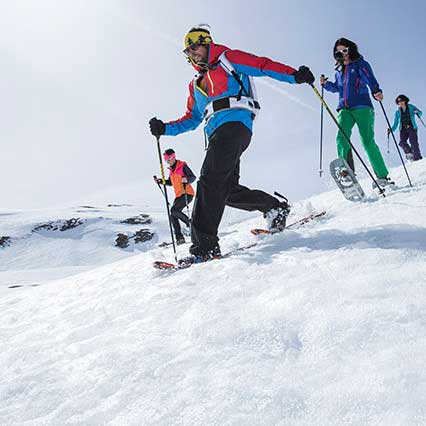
left=320, top=38, right=392, bottom=186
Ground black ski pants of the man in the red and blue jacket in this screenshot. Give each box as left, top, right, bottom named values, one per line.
left=190, top=121, right=279, bottom=255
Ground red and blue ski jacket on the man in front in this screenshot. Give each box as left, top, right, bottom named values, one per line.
left=165, top=43, right=296, bottom=136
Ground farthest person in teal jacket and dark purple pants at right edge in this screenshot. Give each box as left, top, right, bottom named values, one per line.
left=388, top=95, right=423, bottom=161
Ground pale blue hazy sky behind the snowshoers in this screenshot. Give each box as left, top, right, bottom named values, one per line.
left=0, top=0, right=426, bottom=208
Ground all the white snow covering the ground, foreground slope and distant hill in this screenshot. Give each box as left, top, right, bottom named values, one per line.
left=0, top=160, right=426, bottom=426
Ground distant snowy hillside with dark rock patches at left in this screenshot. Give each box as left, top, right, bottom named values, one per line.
left=0, top=204, right=170, bottom=295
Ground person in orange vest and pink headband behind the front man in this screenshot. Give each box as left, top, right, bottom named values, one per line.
left=154, top=149, right=195, bottom=245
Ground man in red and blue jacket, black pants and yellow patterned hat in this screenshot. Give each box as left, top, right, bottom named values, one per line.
left=149, top=26, right=314, bottom=262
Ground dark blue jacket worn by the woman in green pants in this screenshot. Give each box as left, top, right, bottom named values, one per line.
left=323, top=56, right=381, bottom=111
